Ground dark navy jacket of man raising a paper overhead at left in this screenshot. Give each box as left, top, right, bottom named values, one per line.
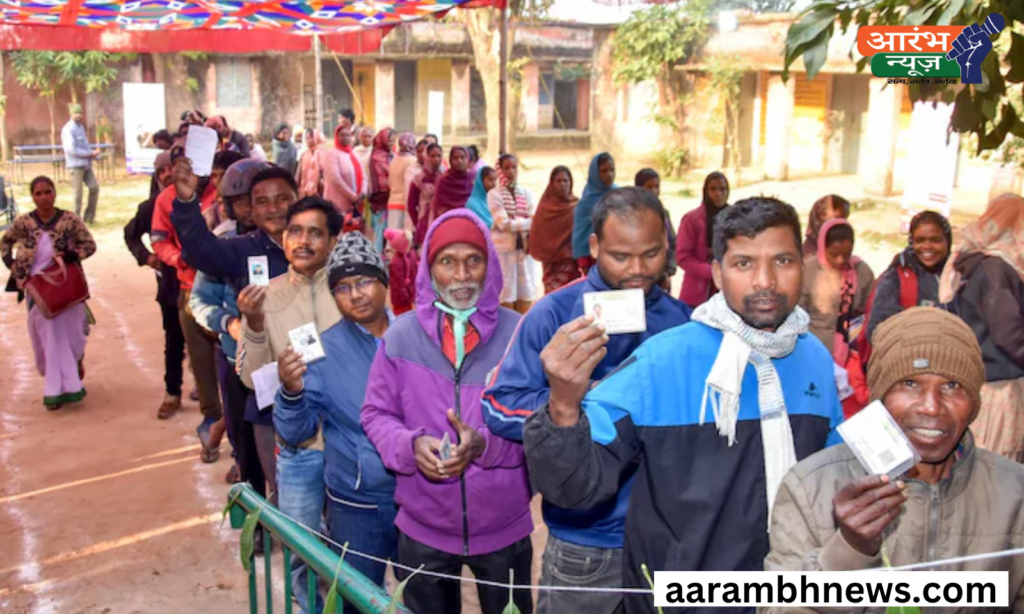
left=171, top=199, right=288, bottom=293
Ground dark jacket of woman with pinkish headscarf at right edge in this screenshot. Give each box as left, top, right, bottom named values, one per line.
left=953, top=253, right=1024, bottom=382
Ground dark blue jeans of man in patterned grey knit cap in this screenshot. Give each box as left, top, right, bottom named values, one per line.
left=327, top=493, right=398, bottom=614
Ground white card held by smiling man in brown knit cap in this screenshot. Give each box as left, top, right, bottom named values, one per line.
left=838, top=401, right=921, bottom=479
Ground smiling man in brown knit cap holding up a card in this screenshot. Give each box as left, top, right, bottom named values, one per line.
left=765, top=307, right=1024, bottom=612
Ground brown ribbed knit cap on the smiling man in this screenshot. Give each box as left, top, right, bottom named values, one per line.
left=867, top=307, right=985, bottom=420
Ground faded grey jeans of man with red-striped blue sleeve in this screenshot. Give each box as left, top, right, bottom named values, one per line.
left=537, top=534, right=623, bottom=614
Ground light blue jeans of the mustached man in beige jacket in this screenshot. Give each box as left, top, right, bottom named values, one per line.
left=278, top=445, right=327, bottom=614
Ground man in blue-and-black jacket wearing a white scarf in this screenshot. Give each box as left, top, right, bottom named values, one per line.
left=523, top=198, right=843, bottom=614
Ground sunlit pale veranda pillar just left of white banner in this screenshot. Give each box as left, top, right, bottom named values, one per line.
left=861, top=79, right=906, bottom=196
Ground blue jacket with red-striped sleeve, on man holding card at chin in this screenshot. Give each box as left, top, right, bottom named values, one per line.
left=483, top=266, right=690, bottom=547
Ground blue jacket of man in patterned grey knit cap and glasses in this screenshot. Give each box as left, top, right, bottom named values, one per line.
left=273, top=319, right=395, bottom=505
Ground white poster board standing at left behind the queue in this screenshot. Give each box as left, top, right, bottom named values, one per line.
left=124, top=83, right=167, bottom=174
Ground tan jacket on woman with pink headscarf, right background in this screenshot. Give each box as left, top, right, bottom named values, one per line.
left=800, top=255, right=874, bottom=354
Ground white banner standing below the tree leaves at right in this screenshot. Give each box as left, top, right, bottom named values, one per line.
left=900, top=102, right=959, bottom=232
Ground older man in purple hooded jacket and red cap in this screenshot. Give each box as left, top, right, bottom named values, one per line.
left=361, top=209, right=534, bottom=614
